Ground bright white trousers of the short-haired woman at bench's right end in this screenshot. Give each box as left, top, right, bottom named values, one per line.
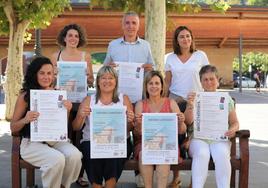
left=189, top=139, right=231, bottom=188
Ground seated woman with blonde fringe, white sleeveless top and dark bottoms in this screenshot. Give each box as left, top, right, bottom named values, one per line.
left=73, top=66, right=134, bottom=188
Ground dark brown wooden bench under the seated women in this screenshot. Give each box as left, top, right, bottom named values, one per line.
left=11, top=130, right=250, bottom=188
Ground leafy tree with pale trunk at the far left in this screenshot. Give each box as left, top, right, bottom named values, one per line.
left=0, top=0, right=69, bottom=120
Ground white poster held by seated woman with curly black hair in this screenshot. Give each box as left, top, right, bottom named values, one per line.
left=30, top=90, right=68, bottom=141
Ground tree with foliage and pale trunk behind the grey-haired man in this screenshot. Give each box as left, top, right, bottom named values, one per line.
left=90, top=0, right=230, bottom=71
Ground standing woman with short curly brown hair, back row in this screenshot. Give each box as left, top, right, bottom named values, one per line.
left=52, top=24, right=94, bottom=86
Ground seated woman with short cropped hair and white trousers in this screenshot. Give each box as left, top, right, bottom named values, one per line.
left=189, top=65, right=239, bottom=188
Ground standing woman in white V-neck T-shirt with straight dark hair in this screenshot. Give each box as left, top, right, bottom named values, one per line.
left=165, top=26, right=209, bottom=187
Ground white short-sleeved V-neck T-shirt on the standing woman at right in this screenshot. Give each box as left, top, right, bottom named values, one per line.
left=165, top=50, right=209, bottom=99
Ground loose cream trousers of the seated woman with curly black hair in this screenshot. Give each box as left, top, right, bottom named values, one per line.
left=20, top=138, right=82, bottom=188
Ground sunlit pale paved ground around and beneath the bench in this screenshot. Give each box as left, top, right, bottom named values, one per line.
left=0, top=89, right=268, bottom=188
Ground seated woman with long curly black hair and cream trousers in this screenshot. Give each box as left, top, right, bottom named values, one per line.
left=10, top=57, right=82, bottom=188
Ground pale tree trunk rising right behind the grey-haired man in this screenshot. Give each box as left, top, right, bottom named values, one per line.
left=145, top=0, right=166, bottom=71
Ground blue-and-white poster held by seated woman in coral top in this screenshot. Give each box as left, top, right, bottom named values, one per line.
left=142, top=113, right=178, bottom=164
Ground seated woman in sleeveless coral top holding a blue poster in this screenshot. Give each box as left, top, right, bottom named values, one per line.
left=135, top=71, right=186, bottom=188
